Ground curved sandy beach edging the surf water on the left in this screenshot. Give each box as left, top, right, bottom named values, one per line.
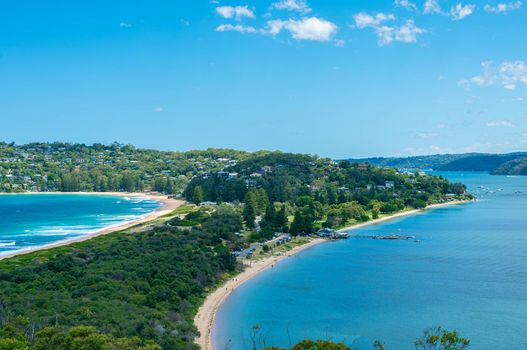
left=0, top=192, right=185, bottom=261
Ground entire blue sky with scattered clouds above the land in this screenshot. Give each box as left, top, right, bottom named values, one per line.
left=0, top=0, right=527, bottom=158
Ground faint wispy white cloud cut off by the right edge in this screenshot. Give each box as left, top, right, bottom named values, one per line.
left=459, top=61, right=527, bottom=90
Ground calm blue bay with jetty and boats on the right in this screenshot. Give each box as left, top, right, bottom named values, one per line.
left=213, top=173, right=527, bottom=350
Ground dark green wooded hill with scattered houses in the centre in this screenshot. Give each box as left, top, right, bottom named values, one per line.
left=184, top=152, right=471, bottom=238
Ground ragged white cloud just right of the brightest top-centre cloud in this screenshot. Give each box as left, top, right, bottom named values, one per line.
left=353, top=12, right=425, bottom=46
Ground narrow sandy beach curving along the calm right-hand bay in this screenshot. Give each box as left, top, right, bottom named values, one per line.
left=194, top=201, right=472, bottom=350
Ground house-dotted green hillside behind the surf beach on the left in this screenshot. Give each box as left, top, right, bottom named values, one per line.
left=0, top=142, right=250, bottom=194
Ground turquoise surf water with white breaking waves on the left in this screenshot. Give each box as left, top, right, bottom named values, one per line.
left=0, top=194, right=160, bottom=256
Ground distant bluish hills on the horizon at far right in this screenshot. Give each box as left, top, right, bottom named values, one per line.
left=348, top=152, right=527, bottom=175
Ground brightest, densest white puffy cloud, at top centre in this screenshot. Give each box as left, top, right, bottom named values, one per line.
left=264, top=17, right=338, bottom=41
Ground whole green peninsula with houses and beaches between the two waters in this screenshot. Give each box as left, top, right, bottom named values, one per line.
left=0, top=144, right=473, bottom=349
